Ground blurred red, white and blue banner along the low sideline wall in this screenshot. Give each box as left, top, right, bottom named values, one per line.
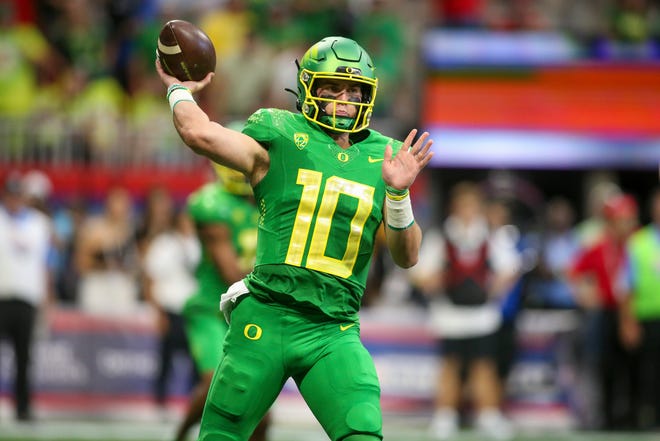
left=0, top=309, right=575, bottom=427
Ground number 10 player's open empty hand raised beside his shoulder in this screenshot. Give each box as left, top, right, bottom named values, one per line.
left=382, top=129, right=433, bottom=190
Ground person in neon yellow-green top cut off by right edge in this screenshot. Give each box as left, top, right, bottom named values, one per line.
left=620, top=188, right=660, bottom=430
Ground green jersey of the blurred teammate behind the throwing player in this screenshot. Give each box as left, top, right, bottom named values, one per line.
left=186, top=183, right=259, bottom=311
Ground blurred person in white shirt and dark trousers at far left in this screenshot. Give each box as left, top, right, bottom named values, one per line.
left=0, top=172, right=54, bottom=421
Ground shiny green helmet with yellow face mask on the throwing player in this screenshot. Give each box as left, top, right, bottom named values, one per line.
left=297, top=37, right=378, bottom=132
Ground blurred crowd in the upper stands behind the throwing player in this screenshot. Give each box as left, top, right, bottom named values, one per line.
left=0, top=0, right=660, bottom=164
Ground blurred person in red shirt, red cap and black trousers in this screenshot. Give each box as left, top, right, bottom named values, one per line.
left=568, top=194, right=638, bottom=430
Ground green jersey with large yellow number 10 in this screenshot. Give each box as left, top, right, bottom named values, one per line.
left=243, top=109, right=401, bottom=320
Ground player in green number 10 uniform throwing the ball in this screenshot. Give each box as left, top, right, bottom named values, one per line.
left=156, top=37, right=432, bottom=441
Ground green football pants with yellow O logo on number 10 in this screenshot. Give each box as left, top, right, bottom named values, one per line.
left=199, top=296, right=382, bottom=441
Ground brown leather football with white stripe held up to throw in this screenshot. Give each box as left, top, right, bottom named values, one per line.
left=156, top=20, right=215, bottom=81
